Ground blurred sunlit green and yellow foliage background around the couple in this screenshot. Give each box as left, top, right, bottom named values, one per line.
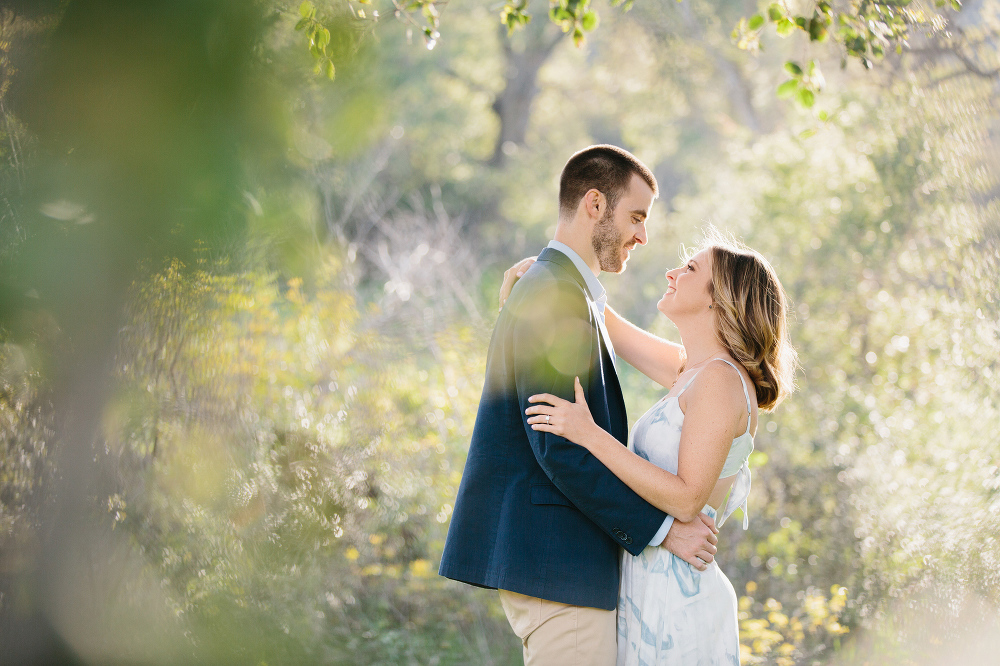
left=0, top=0, right=1000, bottom=666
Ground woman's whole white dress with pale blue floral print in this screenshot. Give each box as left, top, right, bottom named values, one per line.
left=618, top=359, right=753, bottom=666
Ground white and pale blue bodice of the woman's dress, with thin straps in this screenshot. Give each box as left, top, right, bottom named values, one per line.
left=628, top=359, right=753, bottom=529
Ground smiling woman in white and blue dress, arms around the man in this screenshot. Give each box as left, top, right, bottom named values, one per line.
left=501, top=236, right=796, bottom=666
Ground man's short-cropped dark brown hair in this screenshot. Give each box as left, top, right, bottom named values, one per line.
left=559, top=144, right=659, bottom=217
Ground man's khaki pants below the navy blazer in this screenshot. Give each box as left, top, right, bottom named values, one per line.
left=499, top=590, right=618, bottom=666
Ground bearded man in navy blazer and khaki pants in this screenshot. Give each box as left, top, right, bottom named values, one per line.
left=439, top=145, right=717, bottom=666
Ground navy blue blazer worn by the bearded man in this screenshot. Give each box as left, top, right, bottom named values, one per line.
left=438, top=248, right=666, bottom=610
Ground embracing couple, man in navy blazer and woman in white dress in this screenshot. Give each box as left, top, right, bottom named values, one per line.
left=440, top=146, right=795, bottom=666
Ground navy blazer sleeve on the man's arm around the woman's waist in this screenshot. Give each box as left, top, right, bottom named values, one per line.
left=512, top=272, right=667, bottom=555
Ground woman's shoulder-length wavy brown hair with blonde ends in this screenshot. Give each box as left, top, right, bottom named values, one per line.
left=699, top=229, right=798, bottom=412
